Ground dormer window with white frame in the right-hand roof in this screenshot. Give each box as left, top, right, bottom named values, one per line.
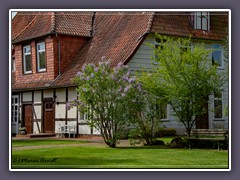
left=194, top=12, right=210, bottom=31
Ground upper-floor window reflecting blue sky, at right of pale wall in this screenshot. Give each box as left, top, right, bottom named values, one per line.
left=212, top=44, right=223, bottom=67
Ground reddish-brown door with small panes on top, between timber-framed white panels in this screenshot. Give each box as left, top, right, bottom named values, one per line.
left=43, top=100, right=55, bottom=133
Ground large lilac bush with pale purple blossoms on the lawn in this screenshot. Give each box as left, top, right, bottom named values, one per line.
left=71, top=58, right=141, bottom=147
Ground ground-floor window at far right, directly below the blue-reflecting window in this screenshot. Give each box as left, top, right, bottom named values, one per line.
left=214, top=92, right=223, bottom=119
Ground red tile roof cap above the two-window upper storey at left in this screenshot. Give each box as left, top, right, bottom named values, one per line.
left=12, top=12, right=93, bottom=43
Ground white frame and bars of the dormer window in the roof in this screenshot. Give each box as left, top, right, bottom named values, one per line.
left=194, top=11, right=210, bottom=31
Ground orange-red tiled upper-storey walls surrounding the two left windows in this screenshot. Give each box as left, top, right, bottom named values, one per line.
left=15, top=35, right=86, bottom=83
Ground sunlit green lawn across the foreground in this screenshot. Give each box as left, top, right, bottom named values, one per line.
left=12, top=140, right=228, bottom=169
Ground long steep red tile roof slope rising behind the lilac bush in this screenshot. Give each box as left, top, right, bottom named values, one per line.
left=53, top=12, right=152, bottom=86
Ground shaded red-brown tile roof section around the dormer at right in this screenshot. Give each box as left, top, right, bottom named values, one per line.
left=151, top=12, right=228, bottom=40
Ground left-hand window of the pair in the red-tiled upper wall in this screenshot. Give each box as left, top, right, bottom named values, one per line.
left=23, top=45, right=32, bottom=74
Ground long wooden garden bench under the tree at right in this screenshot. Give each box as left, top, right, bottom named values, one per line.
left=186, top=129, right=228, bottom=150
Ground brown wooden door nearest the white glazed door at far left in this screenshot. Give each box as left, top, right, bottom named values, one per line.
left=23, top=104, right=33, bottom=134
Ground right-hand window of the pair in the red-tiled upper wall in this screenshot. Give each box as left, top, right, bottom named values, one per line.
left=37, top=42, right=46, bottom=72
